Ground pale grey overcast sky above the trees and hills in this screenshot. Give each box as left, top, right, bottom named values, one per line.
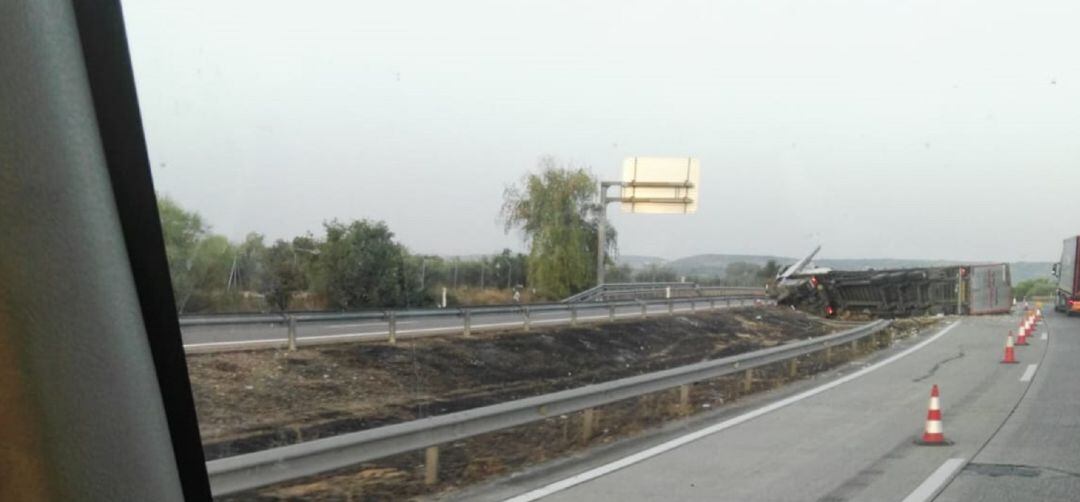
left=123, top=0, right=1080, bottom=260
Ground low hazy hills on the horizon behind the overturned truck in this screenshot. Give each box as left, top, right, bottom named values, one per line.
left=619, top=254, right=1051, bottom=284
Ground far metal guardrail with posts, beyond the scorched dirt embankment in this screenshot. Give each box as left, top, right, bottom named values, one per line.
left=179, top=295, right=765, bottom=352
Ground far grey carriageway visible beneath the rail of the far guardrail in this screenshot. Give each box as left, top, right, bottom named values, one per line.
left=181, top=298, right=752, bottom=352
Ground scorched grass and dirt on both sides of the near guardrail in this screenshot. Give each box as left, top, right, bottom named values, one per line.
left=189, top=308, right=937, bottom=501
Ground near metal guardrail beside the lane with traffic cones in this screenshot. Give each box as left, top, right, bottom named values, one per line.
left=206, top=321, right=889, bottom=496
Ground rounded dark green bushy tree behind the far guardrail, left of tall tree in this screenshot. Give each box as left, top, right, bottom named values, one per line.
left=315, top=219, right=406, bottom=309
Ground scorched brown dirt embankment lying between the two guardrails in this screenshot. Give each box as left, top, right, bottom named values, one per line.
left=188, top=307, right=838, bottom=459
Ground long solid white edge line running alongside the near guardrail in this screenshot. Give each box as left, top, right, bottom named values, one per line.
left=505, top=321, right=960, bottom=502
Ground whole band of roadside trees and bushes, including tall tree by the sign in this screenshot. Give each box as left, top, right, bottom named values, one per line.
left=158, top=158, right=616, bottom=313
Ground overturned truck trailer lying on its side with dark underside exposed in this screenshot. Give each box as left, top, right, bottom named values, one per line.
left=770, top=254, right=1012, bottom=317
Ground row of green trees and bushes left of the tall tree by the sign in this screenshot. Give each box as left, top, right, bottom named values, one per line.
left=158, top=196, right=528, bottom=313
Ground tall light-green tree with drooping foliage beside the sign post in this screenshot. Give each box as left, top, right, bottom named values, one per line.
left=501, top=157, right=616, bottom=298
